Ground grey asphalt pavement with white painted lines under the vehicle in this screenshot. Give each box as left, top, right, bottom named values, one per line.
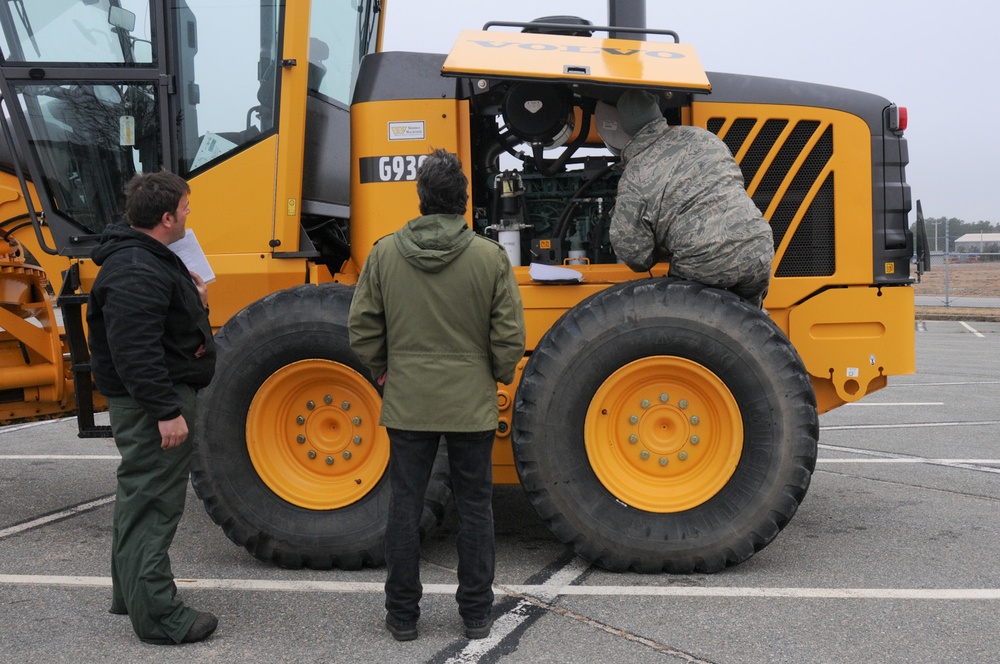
left=0, top=321, right=1000, bottom=664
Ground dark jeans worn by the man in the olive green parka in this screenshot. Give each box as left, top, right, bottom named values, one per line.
left=385, top=429, right=496, bottom=626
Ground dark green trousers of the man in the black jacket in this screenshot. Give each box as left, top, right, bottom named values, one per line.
left=108, top=385, right=198, bottom=644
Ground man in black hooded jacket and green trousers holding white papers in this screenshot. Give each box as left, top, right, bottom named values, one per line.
left=87, top=171, right=218, bottom=644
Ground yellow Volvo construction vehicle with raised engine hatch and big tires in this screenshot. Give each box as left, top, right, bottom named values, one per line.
left=0, top=0, right=914, bottom=572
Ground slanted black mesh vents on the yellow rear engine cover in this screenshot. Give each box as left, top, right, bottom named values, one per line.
left=708, top=118, right=836, bottom=277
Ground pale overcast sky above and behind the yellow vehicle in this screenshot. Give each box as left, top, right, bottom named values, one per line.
left=384, top=0, right=1000, bottom=223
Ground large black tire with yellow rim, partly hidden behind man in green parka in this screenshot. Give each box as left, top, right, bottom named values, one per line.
left=191, top=284, right=450, bottom=569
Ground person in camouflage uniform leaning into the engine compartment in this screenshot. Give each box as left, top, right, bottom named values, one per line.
left=611, top=90, right=774, bottom=306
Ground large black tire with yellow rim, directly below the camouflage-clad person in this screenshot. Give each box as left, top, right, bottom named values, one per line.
left=513, top=279, right=819, bottom=573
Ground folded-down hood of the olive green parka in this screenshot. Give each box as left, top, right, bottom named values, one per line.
left=393, top=214, right=476, bottom=272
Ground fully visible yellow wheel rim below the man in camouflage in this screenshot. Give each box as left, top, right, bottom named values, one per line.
left=584, top=355, right=743, bottom=513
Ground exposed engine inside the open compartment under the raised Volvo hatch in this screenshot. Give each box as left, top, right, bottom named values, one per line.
left=473, top=81, right=620, bottom=265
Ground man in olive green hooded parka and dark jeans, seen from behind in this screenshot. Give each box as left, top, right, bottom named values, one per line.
left=349, top=150, right=525, bottom=641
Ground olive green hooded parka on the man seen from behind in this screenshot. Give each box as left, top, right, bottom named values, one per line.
left=349, top=214, right=525, bottom=432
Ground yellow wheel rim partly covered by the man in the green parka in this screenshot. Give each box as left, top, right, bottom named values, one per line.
left=248, top=359, right=389, bottom=510
